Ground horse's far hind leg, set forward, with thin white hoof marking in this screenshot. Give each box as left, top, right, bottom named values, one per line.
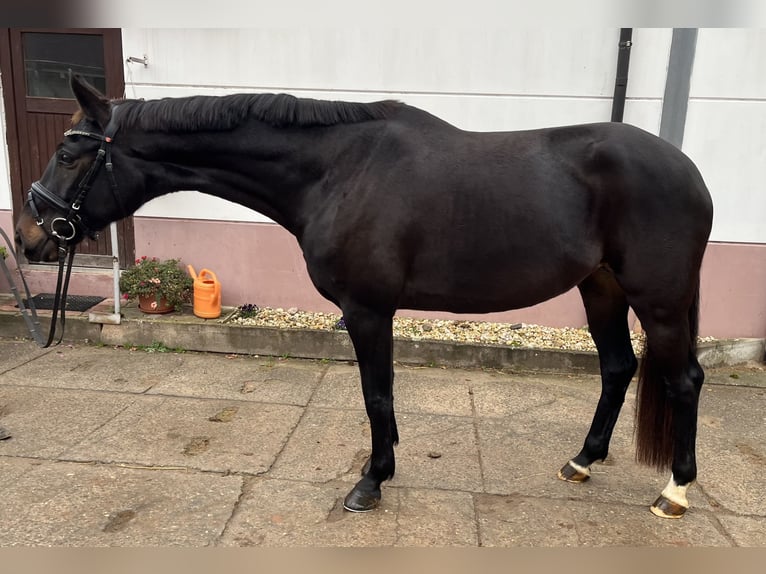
left=558, top=269, right=638, bottom=482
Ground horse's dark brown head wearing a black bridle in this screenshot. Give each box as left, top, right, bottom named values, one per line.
left=16, top=76, right=128, bottom=261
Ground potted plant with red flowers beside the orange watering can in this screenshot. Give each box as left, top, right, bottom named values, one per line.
left=120, top=255, right=194, bottom=313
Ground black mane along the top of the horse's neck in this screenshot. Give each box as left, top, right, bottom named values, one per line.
left=116, top=94, right=402, bottom=131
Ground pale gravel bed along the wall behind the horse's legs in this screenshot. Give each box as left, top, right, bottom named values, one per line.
left=227, top=308, right=676, bottom=354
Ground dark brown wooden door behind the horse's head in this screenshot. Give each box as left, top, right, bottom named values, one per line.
left=0, top=28, right=135, bottom=267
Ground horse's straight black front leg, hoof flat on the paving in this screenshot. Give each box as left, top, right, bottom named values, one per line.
left=343, top=306, right=399, bottom=512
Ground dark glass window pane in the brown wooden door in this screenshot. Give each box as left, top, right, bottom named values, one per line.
left=22, top=32, right=106, bottom=99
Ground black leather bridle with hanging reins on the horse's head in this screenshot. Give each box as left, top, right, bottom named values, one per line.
left=19, top=106, right=125, bottom=347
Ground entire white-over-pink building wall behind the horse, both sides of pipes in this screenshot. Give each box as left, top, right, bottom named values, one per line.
left=0, top=28, right=766, bottom=336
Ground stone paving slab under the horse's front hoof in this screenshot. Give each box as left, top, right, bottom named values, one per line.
left=221, top=479, right=478, bottom=547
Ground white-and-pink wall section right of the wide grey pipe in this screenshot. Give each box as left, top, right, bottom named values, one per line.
left=682, top=28, right=766, bottom=337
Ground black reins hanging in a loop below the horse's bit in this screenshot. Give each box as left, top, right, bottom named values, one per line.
left=0, top=227, right=75, bottom=348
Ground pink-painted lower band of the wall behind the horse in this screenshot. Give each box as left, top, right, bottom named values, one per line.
left=135, top=217, right=766, bottom=337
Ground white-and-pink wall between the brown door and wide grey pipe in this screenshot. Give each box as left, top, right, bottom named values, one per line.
left=123, top=29, right=636, bottom=332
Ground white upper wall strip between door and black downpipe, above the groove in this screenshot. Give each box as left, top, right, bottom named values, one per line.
left=123, top=28, right=619, bottom=97
